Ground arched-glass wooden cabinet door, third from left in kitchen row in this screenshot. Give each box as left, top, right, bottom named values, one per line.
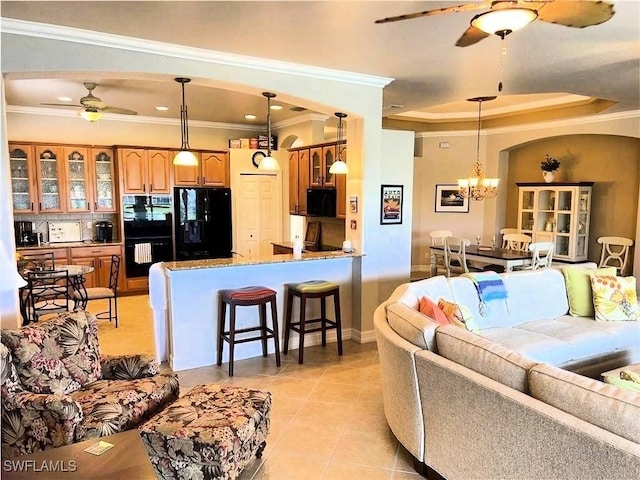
left=62, top=147, right=93, bottom=213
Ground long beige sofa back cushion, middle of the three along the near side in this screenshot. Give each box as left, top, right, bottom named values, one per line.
left=436, top=325, right=536, bottom=393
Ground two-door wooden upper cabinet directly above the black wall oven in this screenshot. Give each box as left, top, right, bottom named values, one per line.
left=117, top=148, right=171, bottom=195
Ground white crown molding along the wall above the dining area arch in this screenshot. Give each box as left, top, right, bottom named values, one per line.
left=416, top=110, right=640, bottom=138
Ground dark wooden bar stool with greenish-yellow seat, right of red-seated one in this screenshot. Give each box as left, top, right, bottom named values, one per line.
left=283, top=280, right=342, bottom=363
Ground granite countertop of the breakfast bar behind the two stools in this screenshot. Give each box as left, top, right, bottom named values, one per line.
left=163, top=250, right=362, bottom=271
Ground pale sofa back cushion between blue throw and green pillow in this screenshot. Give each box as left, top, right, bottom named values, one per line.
left=501, top=268, right=569, bottom=326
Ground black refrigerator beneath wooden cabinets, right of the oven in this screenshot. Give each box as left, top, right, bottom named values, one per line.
left=173, top=187, right=232, bottom=260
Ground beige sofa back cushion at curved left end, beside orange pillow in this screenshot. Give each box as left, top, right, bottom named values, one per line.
left=387, top=302, right=438, bottom=351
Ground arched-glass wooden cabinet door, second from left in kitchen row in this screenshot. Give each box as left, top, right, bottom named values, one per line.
left=35, top=145, right=66, bottom=213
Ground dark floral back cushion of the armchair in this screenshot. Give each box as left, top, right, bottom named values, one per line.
left=1, top=311, right=102, bottom=394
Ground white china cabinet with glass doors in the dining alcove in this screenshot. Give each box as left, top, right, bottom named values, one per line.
left=517, top=182, right=593, bottom=262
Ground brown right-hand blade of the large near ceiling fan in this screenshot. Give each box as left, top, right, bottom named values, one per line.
left=538, top=0, right=615, bottom=28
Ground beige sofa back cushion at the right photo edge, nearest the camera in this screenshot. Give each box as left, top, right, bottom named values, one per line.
left=529, top=364, right=640, bottom=443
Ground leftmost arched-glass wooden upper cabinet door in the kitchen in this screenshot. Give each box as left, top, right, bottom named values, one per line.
left=9, top=143, right=38, bottom=213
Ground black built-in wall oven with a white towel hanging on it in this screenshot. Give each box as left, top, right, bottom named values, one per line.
left=122, top=195, right=173, bottom=278
